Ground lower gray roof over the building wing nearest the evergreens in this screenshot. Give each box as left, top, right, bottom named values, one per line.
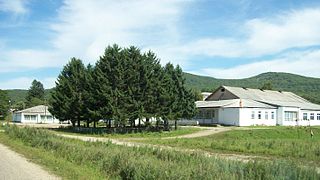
left=196, top=99, right=275, bottom=108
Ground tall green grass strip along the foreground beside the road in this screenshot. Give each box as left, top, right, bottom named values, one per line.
left=0, top=127, right=320, bottom=179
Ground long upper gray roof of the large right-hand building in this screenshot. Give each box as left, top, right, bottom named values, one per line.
left=215, top=86, right=320, bottom=110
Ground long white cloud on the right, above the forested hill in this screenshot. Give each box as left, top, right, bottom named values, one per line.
left=170, top=8, right=320, bottom=57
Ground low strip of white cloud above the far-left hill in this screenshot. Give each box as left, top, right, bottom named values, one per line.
left=0, top=77, right=56, bottom=89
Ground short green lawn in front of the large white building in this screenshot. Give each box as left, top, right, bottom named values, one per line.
left=138, top=127, right=320, bottom=164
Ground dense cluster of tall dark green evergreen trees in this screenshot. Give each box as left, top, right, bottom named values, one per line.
left=49, top=45, right=197, bottom=127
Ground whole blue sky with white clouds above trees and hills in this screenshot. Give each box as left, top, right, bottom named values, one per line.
left=0, top=0, right=320, bottom=89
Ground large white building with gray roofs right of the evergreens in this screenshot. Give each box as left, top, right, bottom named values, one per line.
left=195, top=86, right=320, bottom=126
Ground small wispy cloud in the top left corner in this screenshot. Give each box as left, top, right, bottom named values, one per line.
left=0, top=0, right=28, bottom=15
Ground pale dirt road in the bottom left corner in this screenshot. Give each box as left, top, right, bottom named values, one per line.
left=0, top=144, right=60, bottom=180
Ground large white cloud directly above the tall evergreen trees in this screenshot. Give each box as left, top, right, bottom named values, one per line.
left=52, top=0, right=187, bottom=62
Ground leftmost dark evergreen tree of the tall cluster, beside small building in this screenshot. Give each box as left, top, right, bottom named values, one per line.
left=49, top=58, right=86, bottom=126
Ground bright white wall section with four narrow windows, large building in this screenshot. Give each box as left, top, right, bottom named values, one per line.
left=239, top=108, right=277, bottom=126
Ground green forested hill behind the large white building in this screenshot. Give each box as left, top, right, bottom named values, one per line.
left=185, top=72, right=320, bottom=104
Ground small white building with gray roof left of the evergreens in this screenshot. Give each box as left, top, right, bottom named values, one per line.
left=12, top=105, right=59, bottom=124
